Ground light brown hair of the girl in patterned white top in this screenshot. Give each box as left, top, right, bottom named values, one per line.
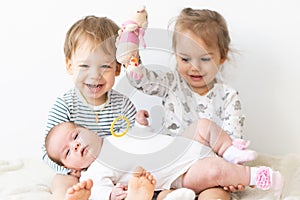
left=172, top=8, right=230, bottom=59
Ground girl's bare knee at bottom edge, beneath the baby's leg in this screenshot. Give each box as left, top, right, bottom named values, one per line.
left=198, top=187, right=231, bottom=200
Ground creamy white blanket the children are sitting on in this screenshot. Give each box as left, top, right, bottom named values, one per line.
left=0, top=154, right=300, bottom=200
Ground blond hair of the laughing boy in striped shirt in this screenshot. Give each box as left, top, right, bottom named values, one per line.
left=64, top=15, right=119, bottom=59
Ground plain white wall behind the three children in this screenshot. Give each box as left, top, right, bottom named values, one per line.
left=0, top=0, right=300, bottom=159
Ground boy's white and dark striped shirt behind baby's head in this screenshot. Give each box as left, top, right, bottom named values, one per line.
left=42, top=88, right=136, bottom=174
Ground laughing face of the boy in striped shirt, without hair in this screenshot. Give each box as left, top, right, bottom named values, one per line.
left=66, top=42, right=117, bottom=105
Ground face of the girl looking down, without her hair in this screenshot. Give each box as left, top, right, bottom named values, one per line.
left=175, top=31, right=225, bottom=95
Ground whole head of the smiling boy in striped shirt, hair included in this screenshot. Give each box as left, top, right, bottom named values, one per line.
left=64, top=16, right=121, bottom=105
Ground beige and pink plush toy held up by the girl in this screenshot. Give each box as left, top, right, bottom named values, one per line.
left=116, top=6, right=148, bottom=65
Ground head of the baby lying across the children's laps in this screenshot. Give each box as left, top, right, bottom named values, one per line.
left=45, top=122, right=102, bottom=170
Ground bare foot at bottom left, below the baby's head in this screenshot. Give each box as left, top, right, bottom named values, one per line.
left=65, top=179, right=93, bottom=200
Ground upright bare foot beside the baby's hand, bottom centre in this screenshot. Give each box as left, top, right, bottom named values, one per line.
left=126, top=167, right=156, bottom=200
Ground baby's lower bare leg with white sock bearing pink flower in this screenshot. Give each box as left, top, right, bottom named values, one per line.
left=182, top=157, right=282, bottom=193
